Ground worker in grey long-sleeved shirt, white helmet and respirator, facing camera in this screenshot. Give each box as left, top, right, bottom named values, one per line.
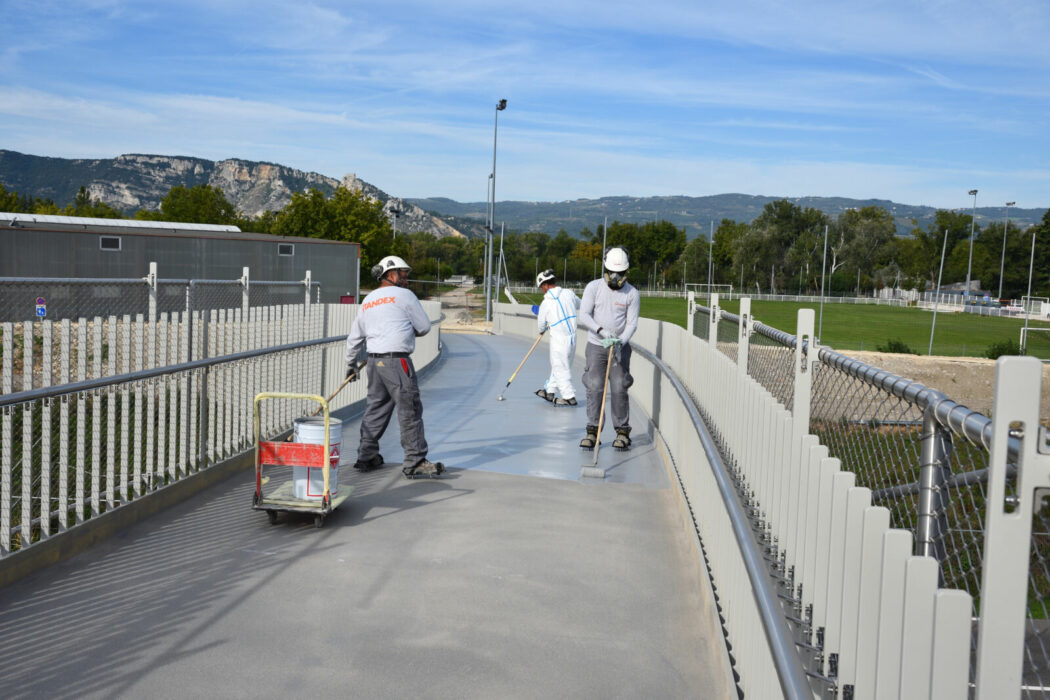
left=579, top=248, right=641, bottom=450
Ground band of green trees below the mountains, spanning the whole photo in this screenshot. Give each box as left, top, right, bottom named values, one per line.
left=0, top=185, right=1050, bottom=298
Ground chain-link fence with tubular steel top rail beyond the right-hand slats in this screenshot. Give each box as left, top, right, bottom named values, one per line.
left=693, top=306, right=1050, bottom=698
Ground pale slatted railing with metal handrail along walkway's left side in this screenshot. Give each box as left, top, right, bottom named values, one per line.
left=0, top=300, right=440, bottom=560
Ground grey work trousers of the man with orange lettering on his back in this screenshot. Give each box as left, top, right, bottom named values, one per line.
left=357, top=357, right=427, bottom=467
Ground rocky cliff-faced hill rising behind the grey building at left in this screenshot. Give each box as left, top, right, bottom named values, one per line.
left=0, top=150, right=463, bottom=237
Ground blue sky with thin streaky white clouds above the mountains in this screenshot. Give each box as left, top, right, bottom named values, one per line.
left=0, top=0, right=1050, bottom=208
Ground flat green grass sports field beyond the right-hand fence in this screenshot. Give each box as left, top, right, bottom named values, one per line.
left=516, top=294, right=1050, bottom=359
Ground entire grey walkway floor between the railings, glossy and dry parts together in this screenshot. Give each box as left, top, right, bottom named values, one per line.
left=0, top=335, right=730, bottom=699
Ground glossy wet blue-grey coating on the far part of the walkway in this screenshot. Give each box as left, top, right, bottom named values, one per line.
left=417, top=334, right=668, bottom=488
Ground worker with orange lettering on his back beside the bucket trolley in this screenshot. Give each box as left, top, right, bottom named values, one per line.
left=347, top=255, right=444, bottom=479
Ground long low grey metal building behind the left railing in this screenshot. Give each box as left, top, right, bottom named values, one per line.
left=0, top=212, right=360, bottom=303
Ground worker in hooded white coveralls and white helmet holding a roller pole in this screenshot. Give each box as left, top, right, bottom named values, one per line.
left=536, top=270, right=580, bottom=406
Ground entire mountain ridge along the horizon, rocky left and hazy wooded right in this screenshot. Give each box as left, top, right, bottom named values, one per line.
left=0, top=149, right=1046, bottom=238
